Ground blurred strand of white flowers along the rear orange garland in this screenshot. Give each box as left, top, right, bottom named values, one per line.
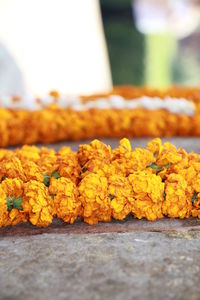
left=0, top=95, right=195, bottom=116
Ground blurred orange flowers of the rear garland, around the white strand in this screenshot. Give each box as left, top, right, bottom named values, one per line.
left=0, top=86, right=200, bottom=147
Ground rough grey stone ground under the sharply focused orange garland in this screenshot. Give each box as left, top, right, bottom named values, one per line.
left=0, top=138, right=200, bottom=300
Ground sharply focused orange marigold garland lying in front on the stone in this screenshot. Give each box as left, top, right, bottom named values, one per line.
left=0, top=138, right=200, bottom=227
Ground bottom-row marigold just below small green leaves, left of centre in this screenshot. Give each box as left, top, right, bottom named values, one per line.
left=49, top=177, right=81, bottom=224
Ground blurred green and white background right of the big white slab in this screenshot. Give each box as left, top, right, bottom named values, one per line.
left=101, top=0, right=200, bottom=87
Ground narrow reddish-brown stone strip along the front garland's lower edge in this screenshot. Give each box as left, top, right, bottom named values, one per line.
left=0, top=216, right=200, bottom=238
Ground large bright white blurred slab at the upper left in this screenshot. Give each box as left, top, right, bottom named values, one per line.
left=0, top=0, right=112, bottom=96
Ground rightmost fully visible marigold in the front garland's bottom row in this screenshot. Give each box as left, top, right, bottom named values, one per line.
left=162, top=174, right=192, bottom=219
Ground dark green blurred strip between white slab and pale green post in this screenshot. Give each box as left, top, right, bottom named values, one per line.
left=101, top=0, right=144, bottom=85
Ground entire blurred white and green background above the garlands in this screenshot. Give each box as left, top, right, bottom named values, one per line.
left=0, top=0, right=200, bottom=96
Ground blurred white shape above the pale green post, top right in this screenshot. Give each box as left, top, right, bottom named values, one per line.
left=133, top=0, right=199, bottom=38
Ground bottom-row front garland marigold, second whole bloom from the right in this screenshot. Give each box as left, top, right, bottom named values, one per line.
left=128, top=171, right=164, bottom=221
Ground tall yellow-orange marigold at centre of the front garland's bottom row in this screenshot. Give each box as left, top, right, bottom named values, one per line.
left=78, top=173, right=111, bottom=224
